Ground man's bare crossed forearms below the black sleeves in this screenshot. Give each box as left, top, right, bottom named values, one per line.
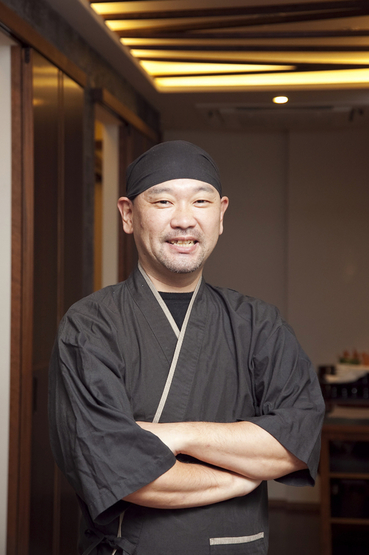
left=125, top=422, right=306, bottom=509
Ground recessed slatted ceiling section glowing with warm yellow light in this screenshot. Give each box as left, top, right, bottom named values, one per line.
left=87, top=0, right=369, bottom=92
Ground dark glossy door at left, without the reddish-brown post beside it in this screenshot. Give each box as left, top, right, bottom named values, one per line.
left=29, top=53, right=83, bottom=555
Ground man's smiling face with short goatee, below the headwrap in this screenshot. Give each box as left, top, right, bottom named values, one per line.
left=119, top=179, right=228, bottom=278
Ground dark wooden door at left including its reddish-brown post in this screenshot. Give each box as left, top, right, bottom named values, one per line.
left=7, top=47, right=84, bottom=555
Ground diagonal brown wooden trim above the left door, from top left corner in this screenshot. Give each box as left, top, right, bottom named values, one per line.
left=0, top=1, right=87, bottom=87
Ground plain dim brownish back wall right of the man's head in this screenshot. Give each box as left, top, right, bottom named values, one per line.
left=164, top=128, right=369, bottom=502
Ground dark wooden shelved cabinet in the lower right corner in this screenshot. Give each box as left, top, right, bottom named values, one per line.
left=320, top=416, right=369, bottom=555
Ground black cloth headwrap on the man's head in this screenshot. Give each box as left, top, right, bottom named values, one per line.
left=126, top=141, right=222, bottom=199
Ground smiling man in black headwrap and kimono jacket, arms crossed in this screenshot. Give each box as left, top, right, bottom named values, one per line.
left=50, top=141, right=324, bottom=555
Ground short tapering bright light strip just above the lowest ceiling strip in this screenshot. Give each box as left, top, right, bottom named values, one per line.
left=140, top=60, right=296, bottom=76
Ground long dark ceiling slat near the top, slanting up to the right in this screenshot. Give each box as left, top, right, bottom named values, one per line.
left=115, top=9, right=369, bottom=38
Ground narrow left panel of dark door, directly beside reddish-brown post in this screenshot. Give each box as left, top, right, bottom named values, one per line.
left=29, top=53, right=60, bottom=555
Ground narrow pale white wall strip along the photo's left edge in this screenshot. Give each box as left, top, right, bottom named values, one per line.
left=0, top=43, right=11, bottom=553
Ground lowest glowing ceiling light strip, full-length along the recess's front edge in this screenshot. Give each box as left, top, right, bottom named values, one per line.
left=155, top=69, right=369, bottom=92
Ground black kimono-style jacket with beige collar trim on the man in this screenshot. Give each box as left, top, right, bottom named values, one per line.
left=49, top=269, right=324, bottom=555
